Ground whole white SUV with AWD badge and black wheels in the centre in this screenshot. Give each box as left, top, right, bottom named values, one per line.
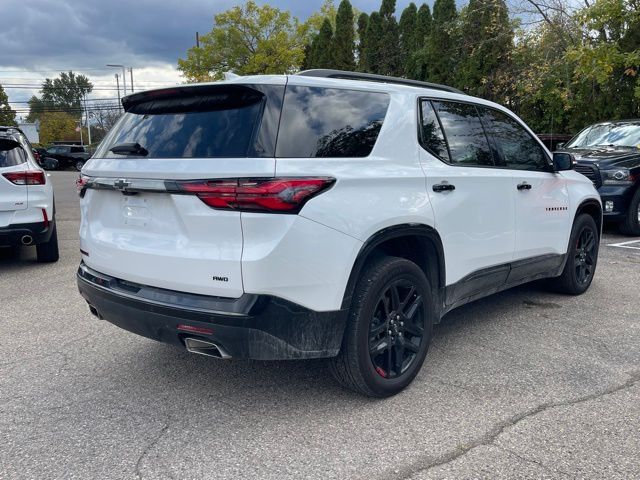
left=78, top=70, right=602, bottom=397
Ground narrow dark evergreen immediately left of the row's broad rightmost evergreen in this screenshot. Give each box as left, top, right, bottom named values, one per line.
left=425, top=0, right=458, bottom=85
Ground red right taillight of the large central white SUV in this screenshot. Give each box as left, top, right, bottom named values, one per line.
left=177, top=177, right=335, bottom=213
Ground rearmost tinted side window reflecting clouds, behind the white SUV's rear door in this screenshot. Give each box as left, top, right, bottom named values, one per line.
left=276, top=85, right=389, bottom=158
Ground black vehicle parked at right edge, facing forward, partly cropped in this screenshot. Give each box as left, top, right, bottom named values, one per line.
left=561, top=119, right=640, bottom=235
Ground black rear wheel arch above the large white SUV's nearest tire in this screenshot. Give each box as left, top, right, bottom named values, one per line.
left=342, top=224, right=445, bottom=309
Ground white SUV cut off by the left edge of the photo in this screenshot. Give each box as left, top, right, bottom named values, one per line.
left=0, top=127, right=58, bottom=262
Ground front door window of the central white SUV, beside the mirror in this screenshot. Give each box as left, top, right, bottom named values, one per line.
left=479, top=107, right=548, bottom=171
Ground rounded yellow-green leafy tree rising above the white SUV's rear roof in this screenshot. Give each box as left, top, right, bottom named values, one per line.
left=178, top=0, right=308, bottom=81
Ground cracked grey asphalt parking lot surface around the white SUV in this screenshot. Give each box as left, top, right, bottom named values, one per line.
left=0, top=171, right=640, bottom=479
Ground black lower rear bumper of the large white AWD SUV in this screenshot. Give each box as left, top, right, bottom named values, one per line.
left=77, top=264, right=347, bottom=360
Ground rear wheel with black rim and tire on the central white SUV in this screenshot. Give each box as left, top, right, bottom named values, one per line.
left=330, top=257, right=434, bottom=398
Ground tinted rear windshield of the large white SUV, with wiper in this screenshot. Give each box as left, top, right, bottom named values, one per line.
left=94, top=85, right=284, bottom=158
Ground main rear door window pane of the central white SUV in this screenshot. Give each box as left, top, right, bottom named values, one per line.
left=433, top=102, right=494, bottom=166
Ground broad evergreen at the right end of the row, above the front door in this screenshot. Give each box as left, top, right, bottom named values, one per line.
left=457, top=0, right=514, bottom=101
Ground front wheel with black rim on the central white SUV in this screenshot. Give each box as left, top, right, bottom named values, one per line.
left=550, top=214, right=600, bottom=295
